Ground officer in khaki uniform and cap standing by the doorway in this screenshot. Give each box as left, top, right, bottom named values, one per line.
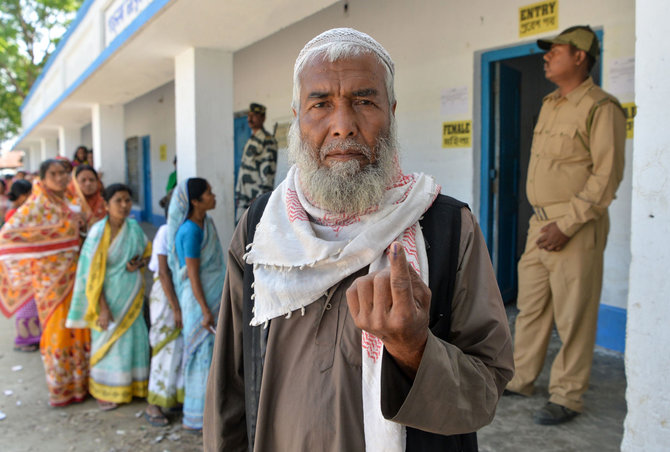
left=506, top=26, right=626, bottom=425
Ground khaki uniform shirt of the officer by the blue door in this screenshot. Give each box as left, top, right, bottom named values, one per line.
left=526, top=77, right=626, bottom=237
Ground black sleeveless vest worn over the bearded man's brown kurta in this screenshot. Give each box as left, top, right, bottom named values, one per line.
left=242, top=193, right=478, bottom=452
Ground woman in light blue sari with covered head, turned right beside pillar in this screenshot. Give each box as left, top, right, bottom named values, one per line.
left=168, top=177, right=226, bottom=430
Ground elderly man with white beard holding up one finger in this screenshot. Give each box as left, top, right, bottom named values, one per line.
left=203, top=29, right=513, bottom=451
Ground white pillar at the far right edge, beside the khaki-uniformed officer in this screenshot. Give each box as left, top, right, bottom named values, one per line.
left=621, top=0, right=670, bottom=452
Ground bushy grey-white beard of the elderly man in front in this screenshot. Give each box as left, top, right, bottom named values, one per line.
left=288, top=118, right=398, bottom=216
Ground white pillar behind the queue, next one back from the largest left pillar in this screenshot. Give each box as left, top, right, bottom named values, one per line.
left=91, top=104, right=126, bottom=185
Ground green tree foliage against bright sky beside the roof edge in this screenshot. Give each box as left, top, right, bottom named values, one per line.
left=0, top=0, right=82, bottom=141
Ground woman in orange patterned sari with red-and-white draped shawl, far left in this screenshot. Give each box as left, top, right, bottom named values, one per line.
left=0, top=160, right=90, bottom=406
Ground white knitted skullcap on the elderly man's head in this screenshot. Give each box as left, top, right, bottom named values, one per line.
left=293, top=28, right=395, bottom=77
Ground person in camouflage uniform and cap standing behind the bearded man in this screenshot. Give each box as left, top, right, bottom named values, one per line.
left=235, top=103, right=277, bottom=223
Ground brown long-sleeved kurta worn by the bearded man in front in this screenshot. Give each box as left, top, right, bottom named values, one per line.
left=204, top=209, right=513, bottom=451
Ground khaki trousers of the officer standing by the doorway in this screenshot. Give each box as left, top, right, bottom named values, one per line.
left=507, top=214, right=609, bottom=412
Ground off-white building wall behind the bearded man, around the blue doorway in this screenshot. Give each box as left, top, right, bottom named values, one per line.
left=234, top=0, right=635, bottom=307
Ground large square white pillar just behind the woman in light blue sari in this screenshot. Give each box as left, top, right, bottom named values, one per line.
left=175, top=48, right=235, bottom=245
